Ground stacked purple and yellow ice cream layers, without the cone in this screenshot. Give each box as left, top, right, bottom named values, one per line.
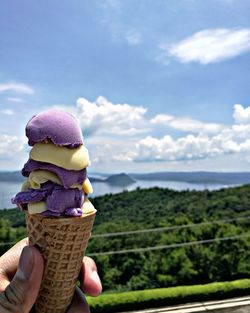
left=12, top=109, right=92, bottom=217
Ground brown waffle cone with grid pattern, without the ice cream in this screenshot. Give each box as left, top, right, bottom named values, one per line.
left=26, top=211, right=95, bottom=313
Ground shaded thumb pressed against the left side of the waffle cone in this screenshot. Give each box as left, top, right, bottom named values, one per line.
left=0, top=247, right=43, bottom=313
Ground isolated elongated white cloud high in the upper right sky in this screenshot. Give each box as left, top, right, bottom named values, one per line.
left=160, top=28, right=250, bottom=64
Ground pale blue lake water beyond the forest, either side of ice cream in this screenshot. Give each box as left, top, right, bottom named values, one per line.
left=0, top=180, right=234, bottom=209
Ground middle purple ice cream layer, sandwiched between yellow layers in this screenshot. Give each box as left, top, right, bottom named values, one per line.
left=22, top=159, right=87, bottom=189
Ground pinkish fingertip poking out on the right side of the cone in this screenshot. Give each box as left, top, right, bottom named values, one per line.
left=81, top=257, right=102, bottom=297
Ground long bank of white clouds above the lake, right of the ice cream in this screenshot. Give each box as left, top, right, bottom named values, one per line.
left=57, top=97, right=250, bottom=166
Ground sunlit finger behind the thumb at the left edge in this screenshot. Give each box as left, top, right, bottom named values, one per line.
left=0, top=238, right=28, bottom=292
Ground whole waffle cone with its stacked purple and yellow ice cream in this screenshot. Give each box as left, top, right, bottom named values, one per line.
left=12, top=109, right=96, bottom=313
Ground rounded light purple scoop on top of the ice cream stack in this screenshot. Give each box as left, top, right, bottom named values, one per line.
left=25, top=109, right=83, bottom=148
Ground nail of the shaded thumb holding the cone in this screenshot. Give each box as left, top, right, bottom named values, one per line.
left=16, top=247, right=34, bottom=279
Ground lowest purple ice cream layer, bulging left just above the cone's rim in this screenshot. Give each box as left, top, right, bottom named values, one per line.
left=11, top=182, right=84, bottom=216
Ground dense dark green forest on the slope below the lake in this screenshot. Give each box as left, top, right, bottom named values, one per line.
left=0, top=185, right=250, bottom=292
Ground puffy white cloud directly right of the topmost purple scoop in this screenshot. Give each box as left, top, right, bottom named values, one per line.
left=76, top=97, right=147, bottom=136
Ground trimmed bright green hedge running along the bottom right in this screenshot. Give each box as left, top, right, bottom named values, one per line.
left=88, top=279, right=250, bottom=313
